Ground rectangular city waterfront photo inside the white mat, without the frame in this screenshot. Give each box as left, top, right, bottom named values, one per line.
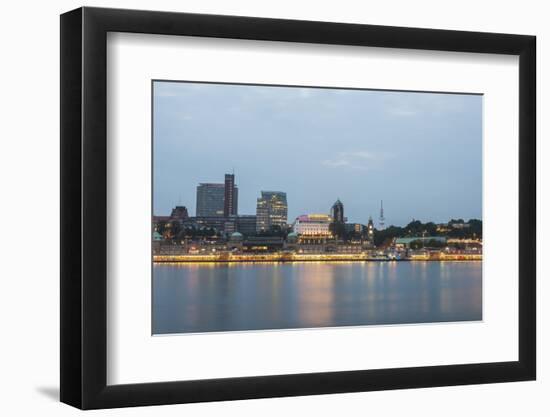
left=151, top=81, right=483, bottom=335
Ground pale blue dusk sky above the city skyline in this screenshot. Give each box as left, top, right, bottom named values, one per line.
left=153, top=81, right=483, bottom=226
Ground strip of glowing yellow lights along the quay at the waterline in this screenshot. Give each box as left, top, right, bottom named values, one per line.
left=153, top=252, right=483, bottom=263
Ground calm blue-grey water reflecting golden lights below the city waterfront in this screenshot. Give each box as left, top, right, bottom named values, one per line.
left=153, top=262, right=482, bottom=334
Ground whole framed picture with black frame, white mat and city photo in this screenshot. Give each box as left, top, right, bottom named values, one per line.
left=60, top=7, right=536, bottom=409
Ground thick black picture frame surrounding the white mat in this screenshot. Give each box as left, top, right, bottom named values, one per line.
left=60, top=7, right=536, bottom=409
